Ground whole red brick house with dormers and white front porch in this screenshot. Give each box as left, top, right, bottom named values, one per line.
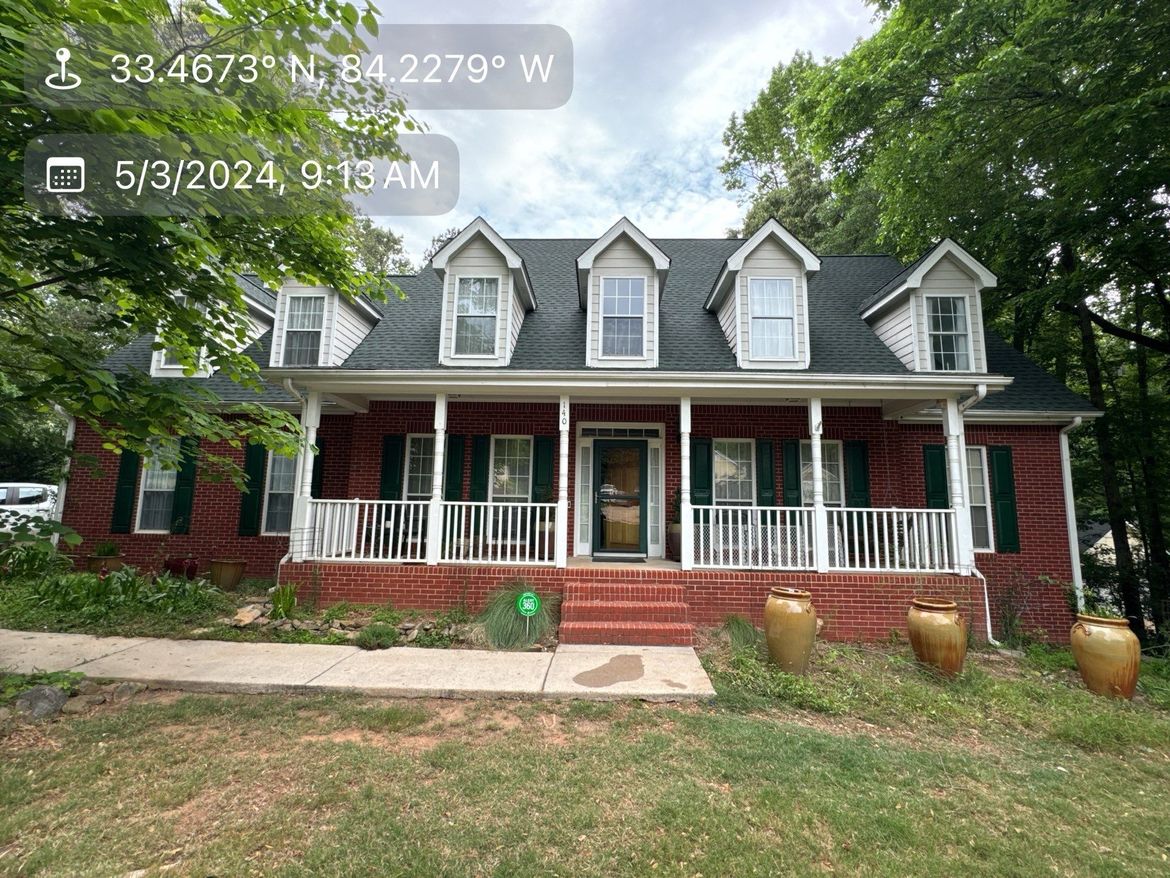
left=54, top=219, right=1096, bottom=643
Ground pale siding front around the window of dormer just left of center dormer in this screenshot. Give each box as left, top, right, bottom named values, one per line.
left=440, top=235, right=510, bottom=366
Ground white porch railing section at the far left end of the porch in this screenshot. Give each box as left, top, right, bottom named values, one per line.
left=305, top=500, right=429, bottom=563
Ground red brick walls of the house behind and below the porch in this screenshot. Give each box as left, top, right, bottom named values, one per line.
left=59, top=400, right=1072, bottom=639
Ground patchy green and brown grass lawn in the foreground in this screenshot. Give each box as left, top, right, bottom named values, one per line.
left=0, top=637, right=1170, bottom=876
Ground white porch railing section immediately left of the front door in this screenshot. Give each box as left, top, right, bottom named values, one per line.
left=439, top=502, right=557, bottom=564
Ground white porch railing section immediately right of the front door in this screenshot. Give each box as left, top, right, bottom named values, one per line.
left=694, top=506, right=815, bottom=570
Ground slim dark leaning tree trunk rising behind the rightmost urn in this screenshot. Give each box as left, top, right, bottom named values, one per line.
left=1075, top=302, right=1145, bottom=640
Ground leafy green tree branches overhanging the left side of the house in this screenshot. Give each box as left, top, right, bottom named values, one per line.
left=0, top=0, right=413, bottom=478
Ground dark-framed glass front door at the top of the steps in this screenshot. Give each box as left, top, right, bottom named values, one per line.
left=593, top=439, right=646, bottom=555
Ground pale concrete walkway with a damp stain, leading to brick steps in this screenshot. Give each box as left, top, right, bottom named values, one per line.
left=0, top=629, right=715, bottom=701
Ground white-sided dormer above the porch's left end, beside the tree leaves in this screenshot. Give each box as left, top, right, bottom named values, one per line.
left=269, top=281, right=378, bottom=368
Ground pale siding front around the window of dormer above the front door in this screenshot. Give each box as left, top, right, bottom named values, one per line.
left=586, top=235, right=659, bottom=369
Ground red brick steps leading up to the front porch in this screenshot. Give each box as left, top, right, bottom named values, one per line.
left=559, top=582, right=695, bottom=646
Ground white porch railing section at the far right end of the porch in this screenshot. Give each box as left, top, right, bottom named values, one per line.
left=827, top=508, right=958, bottom=572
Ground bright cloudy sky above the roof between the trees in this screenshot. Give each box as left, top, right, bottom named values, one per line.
left=380, top=0, right=874, bottom=260
